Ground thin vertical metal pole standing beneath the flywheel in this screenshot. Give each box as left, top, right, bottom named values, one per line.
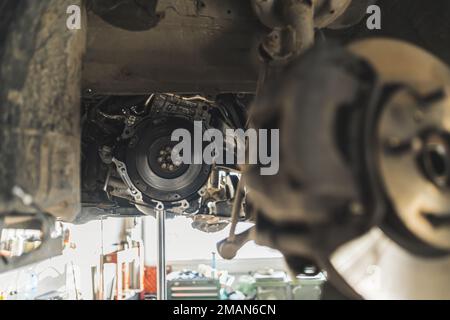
left=156, top=210, right=167, bottom=300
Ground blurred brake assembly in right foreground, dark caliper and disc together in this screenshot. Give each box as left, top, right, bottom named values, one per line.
left=245, top=39, right=450, bottom=298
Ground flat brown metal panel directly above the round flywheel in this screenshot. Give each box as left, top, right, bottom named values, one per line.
left=83, top=0, right=267, bottom=94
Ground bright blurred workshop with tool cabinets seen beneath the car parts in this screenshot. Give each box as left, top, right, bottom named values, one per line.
left=0, top=217, right=324, bottom=300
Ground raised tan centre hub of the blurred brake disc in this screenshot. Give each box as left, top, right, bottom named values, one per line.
left=377, top=88, right=450, bottom=249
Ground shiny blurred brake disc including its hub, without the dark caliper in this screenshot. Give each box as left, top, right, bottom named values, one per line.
left=331, top=39, right=450, bottom=299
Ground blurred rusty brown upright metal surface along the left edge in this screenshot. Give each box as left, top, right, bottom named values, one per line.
left=0, top=0, right=84, bottom=220
